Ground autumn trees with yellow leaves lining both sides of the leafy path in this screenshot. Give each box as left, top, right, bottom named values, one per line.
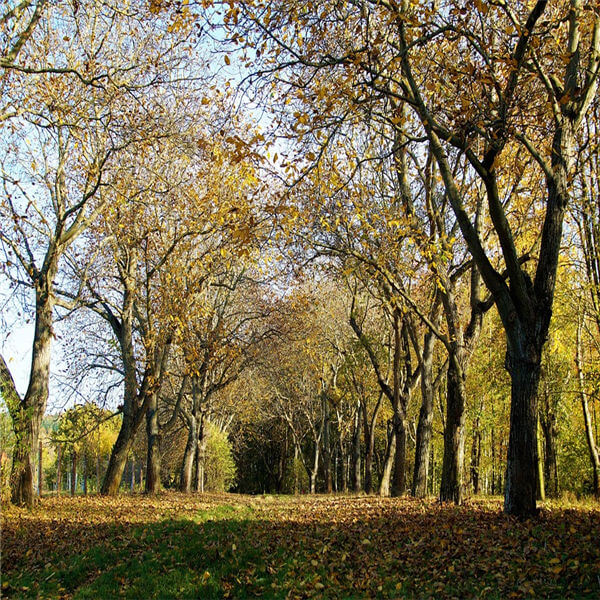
left=0, top=0, right=600, bottom=516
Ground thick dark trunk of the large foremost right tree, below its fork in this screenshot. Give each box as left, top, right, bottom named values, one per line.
left=504, top=357, right=540, bottom=517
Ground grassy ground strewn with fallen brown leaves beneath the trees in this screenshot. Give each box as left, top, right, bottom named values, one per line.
left=1, top=492, right=600, bottom=599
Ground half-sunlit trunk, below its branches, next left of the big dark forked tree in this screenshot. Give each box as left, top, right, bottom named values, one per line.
left=440, top=357, right=465, bottom=504
